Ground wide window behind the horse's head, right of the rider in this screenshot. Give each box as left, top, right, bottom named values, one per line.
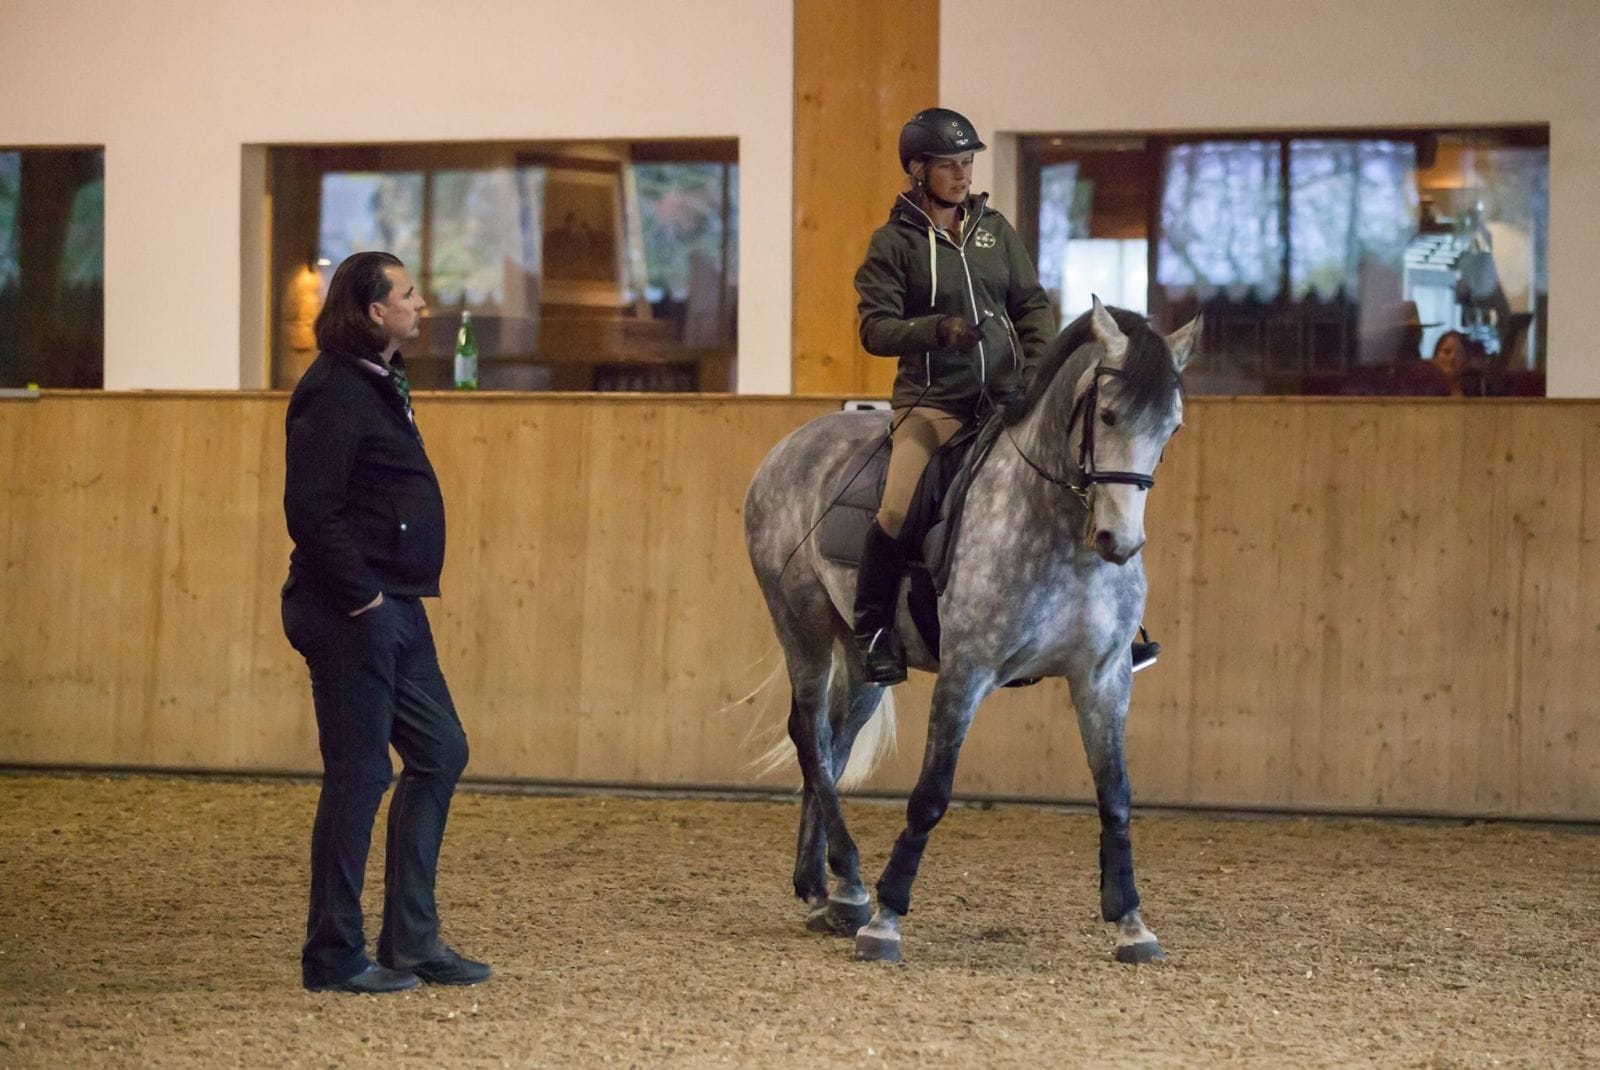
left=1021, top=126, right=1549, bottom=393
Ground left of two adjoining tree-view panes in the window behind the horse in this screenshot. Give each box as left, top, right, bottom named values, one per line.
left=1157, top=141, right=1283, bottom=302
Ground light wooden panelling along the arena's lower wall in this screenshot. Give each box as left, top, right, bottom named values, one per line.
left=0, top=393, right=1600, bottom=819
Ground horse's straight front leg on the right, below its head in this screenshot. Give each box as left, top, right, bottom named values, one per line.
left=1067, top=649, right=1165, bottom=963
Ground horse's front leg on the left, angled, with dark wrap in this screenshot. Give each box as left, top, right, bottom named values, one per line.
left=856, top=664, right=994, bottom=963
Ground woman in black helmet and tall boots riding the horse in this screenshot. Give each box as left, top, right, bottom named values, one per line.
left=854, top=107, right=1158, bottom=685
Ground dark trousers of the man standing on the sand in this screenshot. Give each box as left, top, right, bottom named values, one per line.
left=283, top=579, right=467, bottom=985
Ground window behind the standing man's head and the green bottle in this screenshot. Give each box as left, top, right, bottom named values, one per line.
left=269, top=141, right=738, bottom=390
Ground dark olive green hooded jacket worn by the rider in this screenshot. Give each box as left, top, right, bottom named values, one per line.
left=856, top=194, right=1056, bottom=417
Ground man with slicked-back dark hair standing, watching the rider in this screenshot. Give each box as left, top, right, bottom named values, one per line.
left=283, top=253, right=490, bottom=993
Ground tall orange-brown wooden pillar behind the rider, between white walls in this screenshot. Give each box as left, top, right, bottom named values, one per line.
left=794, top=0, right=939, bottom=397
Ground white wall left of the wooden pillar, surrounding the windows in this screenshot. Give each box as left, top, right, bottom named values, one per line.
left=0, top=0, right=794, bottom=393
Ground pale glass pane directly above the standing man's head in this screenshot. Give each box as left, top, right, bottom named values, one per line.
left=317, top=171, right=422, bottom=270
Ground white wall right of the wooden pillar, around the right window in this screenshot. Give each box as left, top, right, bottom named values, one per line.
left=941, top=0, right=1600, bottom=397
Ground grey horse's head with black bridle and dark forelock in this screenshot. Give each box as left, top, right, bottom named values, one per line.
left=1069, top=297, right=1200, bottom=565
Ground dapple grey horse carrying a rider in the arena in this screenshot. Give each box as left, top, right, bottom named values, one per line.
left=744, top=297, right=1202, bottom=963
